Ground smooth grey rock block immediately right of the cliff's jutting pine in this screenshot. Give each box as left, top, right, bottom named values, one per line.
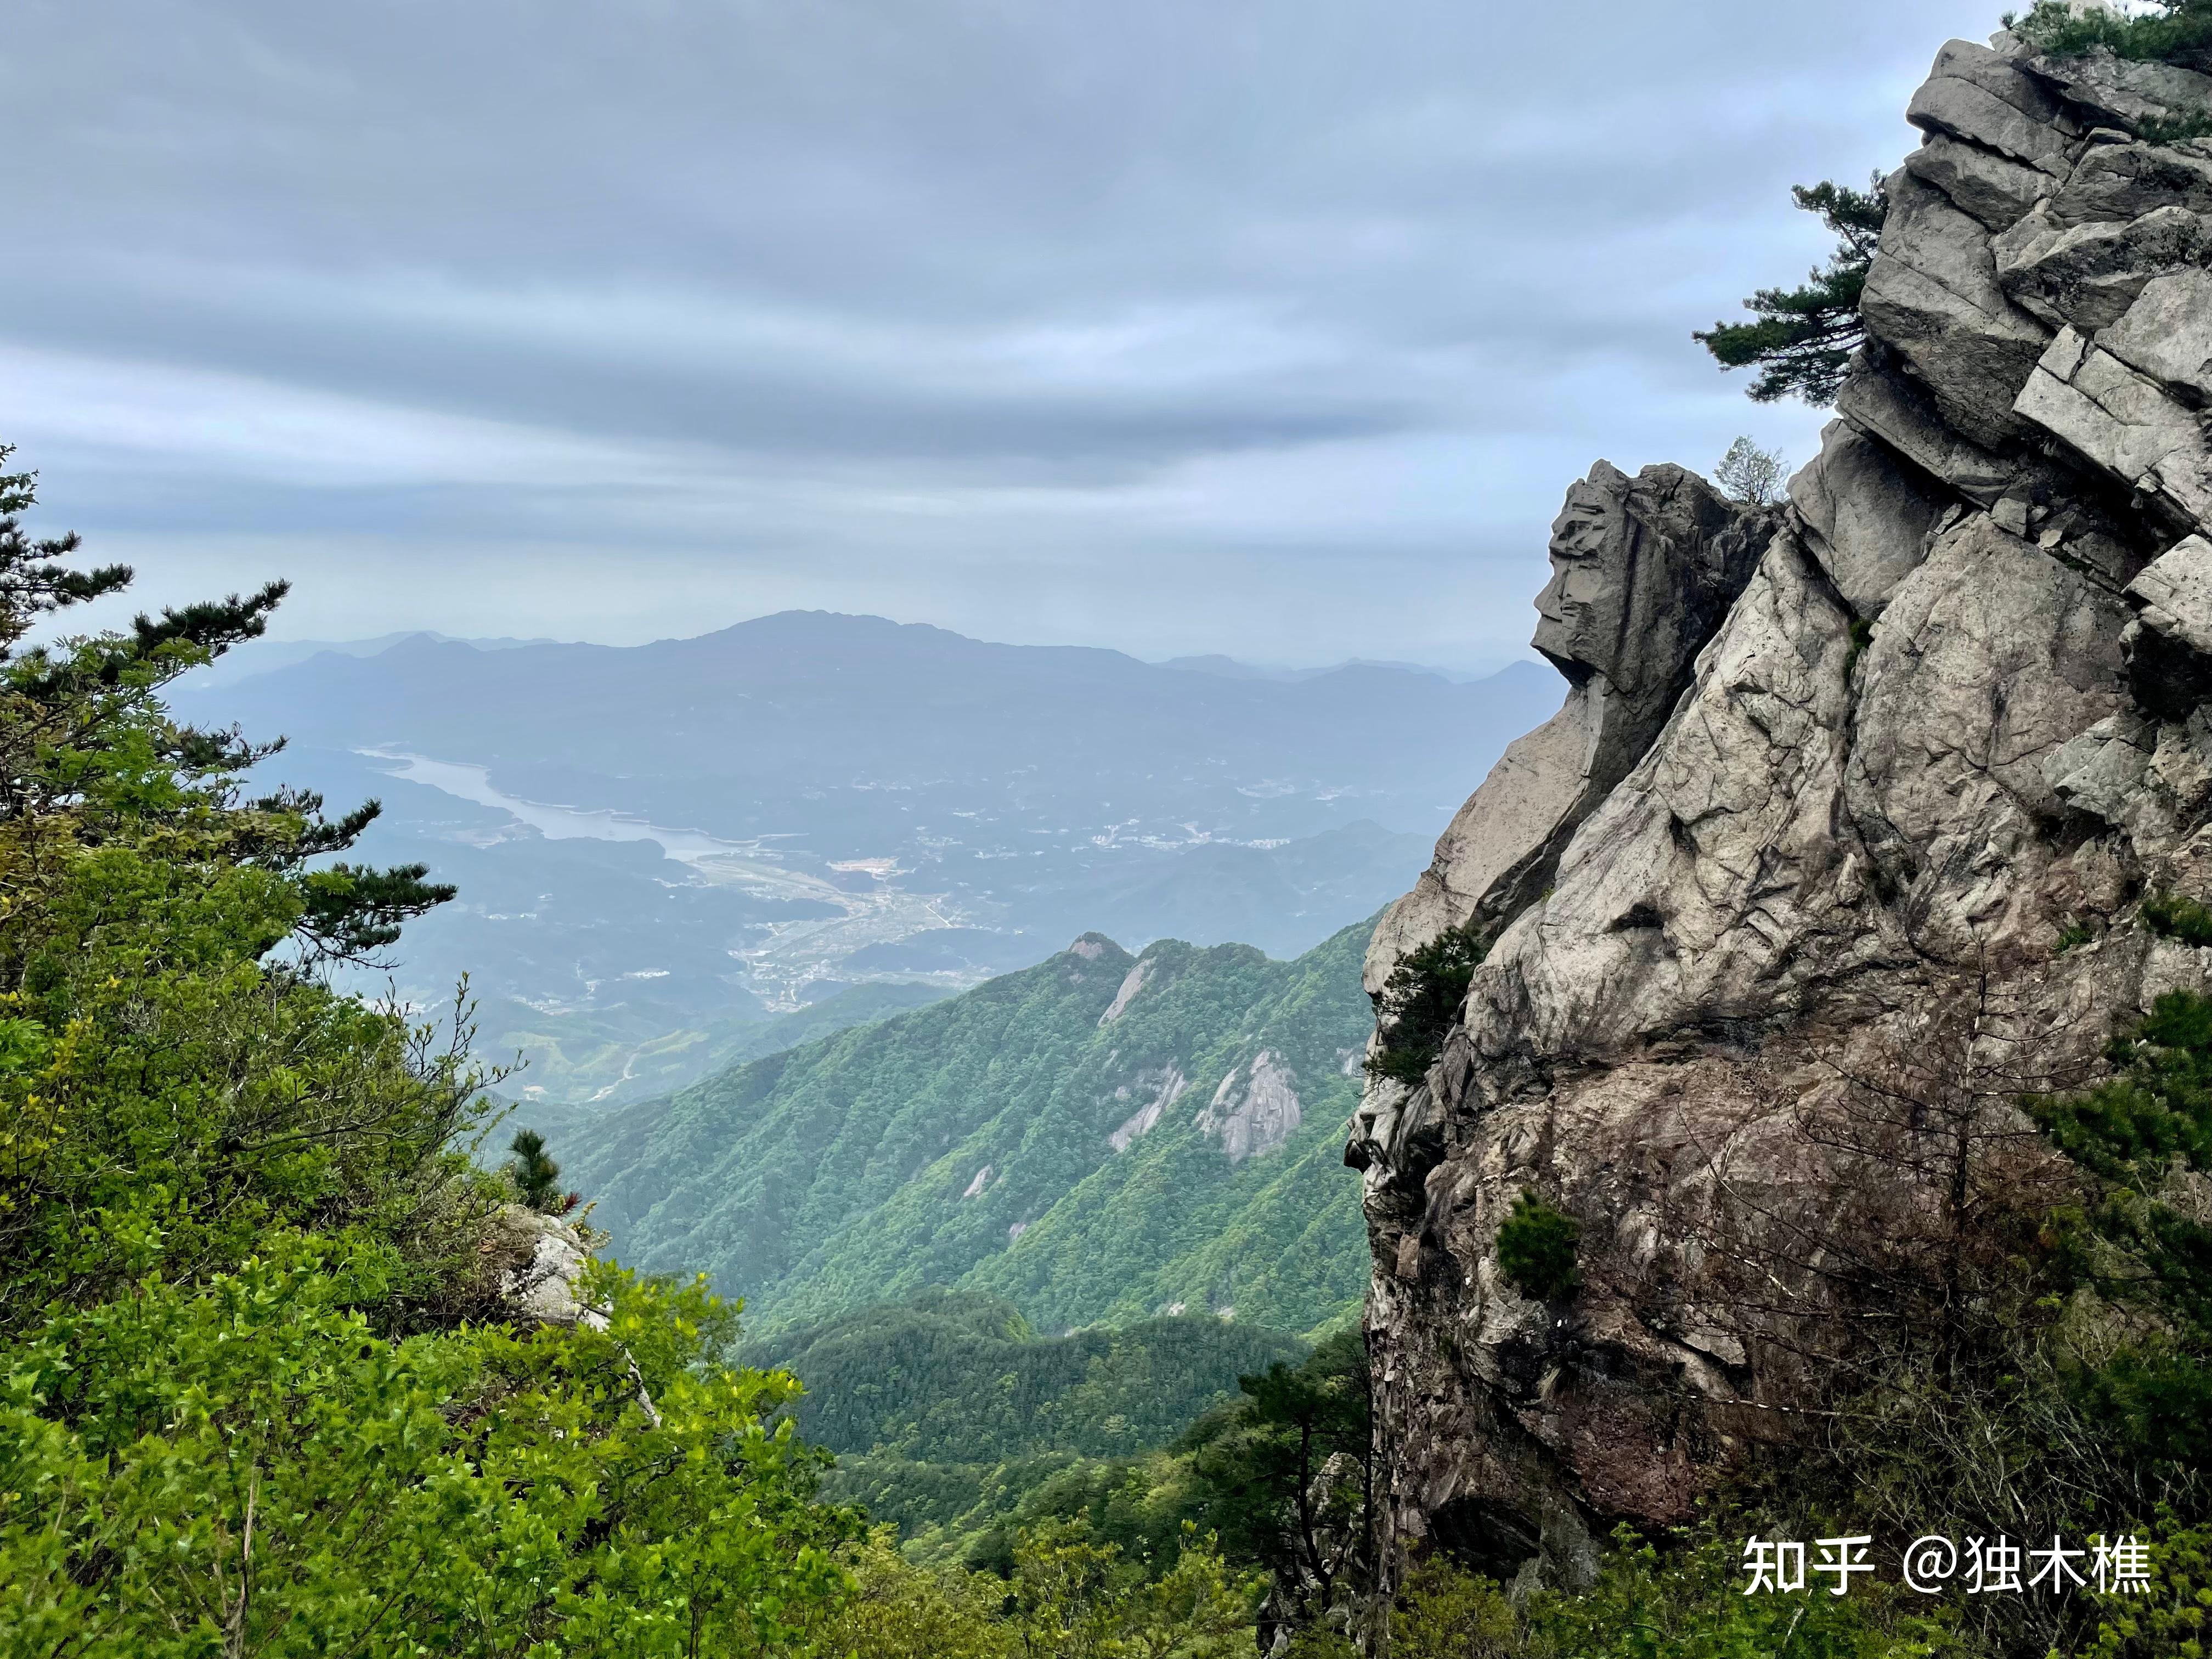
left=1858, top=172, right=2051, bottom=449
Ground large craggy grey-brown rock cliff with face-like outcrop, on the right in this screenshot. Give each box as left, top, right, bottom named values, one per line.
left=1347, top=36, right=2212, bottom=1582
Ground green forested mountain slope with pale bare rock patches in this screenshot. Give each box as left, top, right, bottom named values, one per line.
left=553, top=922, right=1369, bottom=1331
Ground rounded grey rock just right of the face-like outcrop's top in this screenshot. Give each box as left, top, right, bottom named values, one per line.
left=1790, top=420, right=1944, bottom=617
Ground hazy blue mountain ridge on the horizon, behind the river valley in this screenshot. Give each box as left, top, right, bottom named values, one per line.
left=195, top=613, right=1558, bottom=858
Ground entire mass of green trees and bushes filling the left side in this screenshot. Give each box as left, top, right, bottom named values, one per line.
left=0, top=438, right=876, bottom=1659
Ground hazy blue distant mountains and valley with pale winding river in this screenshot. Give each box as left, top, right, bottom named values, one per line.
left=194, top=613, right=1562, bottom=1104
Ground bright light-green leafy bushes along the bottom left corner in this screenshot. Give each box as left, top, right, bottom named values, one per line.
left=0, top=1237, right=854, bottom=1659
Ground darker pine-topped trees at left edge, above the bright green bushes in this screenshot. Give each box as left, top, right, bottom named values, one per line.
left=0, top=449, right=491, bottom=1336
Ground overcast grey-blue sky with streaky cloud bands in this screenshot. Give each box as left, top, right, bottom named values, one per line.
left=0, top=0, right=1997, bottom=670
